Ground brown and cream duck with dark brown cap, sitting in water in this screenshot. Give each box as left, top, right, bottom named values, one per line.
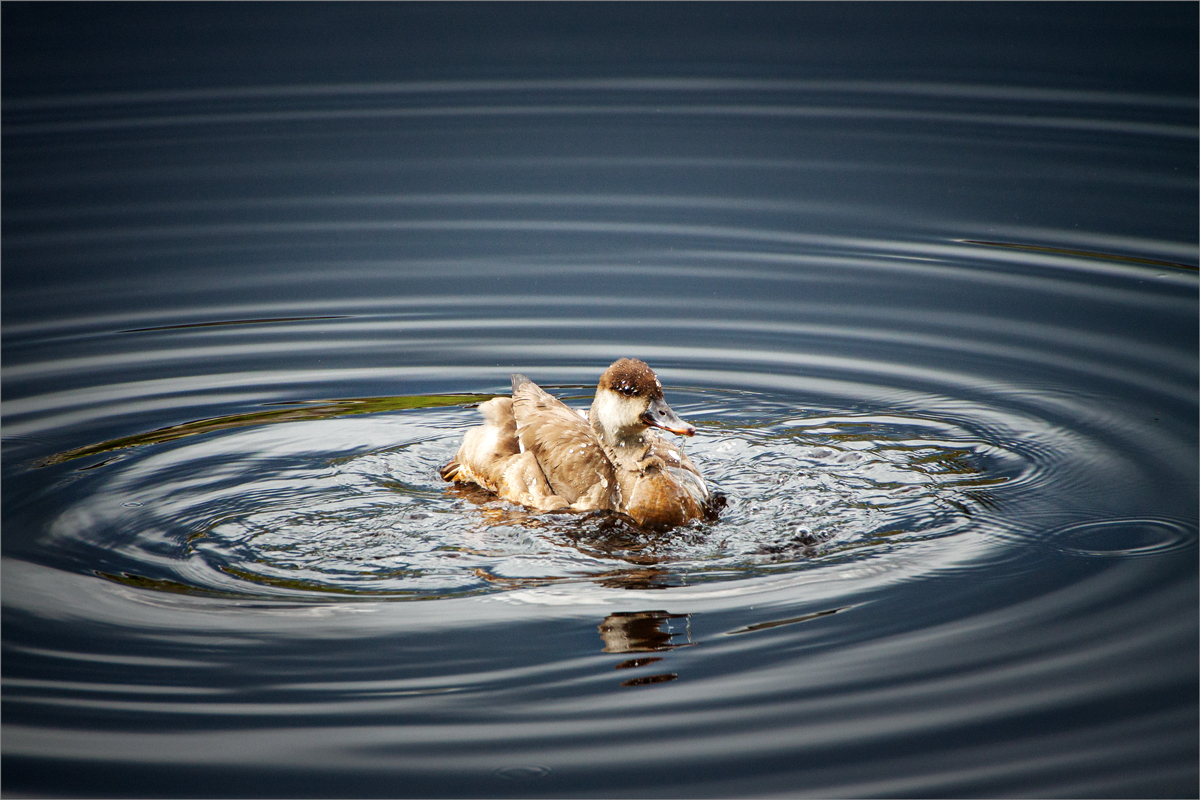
left=442, top=359, right=719, bottom=529
